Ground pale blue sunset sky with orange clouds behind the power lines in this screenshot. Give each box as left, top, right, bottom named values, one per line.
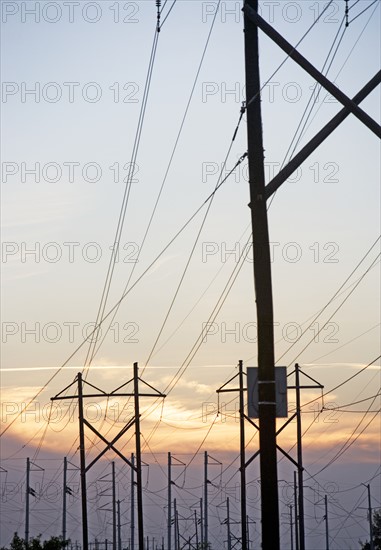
left=0, top=0, right=381, bottom=550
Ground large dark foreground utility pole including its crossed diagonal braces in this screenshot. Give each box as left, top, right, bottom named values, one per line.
left=241, top=0, right=381, bottom=550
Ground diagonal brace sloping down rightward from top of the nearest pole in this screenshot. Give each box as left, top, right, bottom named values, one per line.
left=244, top=4, right=381, bottom=138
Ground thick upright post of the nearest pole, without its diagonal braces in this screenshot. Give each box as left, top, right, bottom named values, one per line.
left=244, top=0, right=279, bottom=550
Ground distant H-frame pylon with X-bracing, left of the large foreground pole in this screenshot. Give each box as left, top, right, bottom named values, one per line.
left=51, top=363, right=165, bottom=550
